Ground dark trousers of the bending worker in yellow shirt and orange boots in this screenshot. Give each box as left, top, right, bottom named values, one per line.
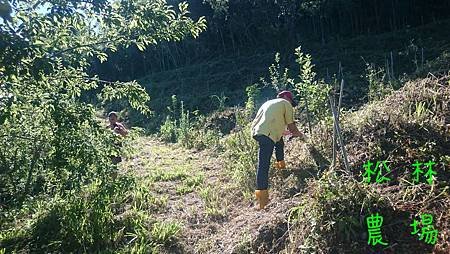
left=253, top=135, right=284, bottom=190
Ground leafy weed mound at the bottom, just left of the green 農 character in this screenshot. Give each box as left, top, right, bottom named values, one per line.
left=288, top=172, right=384, bottom=253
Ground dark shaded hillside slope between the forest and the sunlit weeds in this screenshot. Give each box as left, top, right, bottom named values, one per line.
left=139, top=20, right=450, bottom=125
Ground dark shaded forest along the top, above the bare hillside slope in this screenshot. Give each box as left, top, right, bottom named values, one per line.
left=94, top=0, right=450, bottom=80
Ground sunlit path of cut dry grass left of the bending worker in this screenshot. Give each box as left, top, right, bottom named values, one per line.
left=122, top=137, right=295, bottom=253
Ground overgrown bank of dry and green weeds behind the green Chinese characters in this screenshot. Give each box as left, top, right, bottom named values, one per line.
left=286, top=76, right=450, bottom=253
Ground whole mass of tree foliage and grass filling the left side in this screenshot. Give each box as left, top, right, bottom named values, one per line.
left=0, top=1, right=206, bottom=252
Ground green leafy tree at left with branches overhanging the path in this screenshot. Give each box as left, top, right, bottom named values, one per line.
left=0, top=0, right=206, bottom=204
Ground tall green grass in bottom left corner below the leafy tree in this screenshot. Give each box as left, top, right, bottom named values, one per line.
left=0, top=178, right=161, bottom=253
